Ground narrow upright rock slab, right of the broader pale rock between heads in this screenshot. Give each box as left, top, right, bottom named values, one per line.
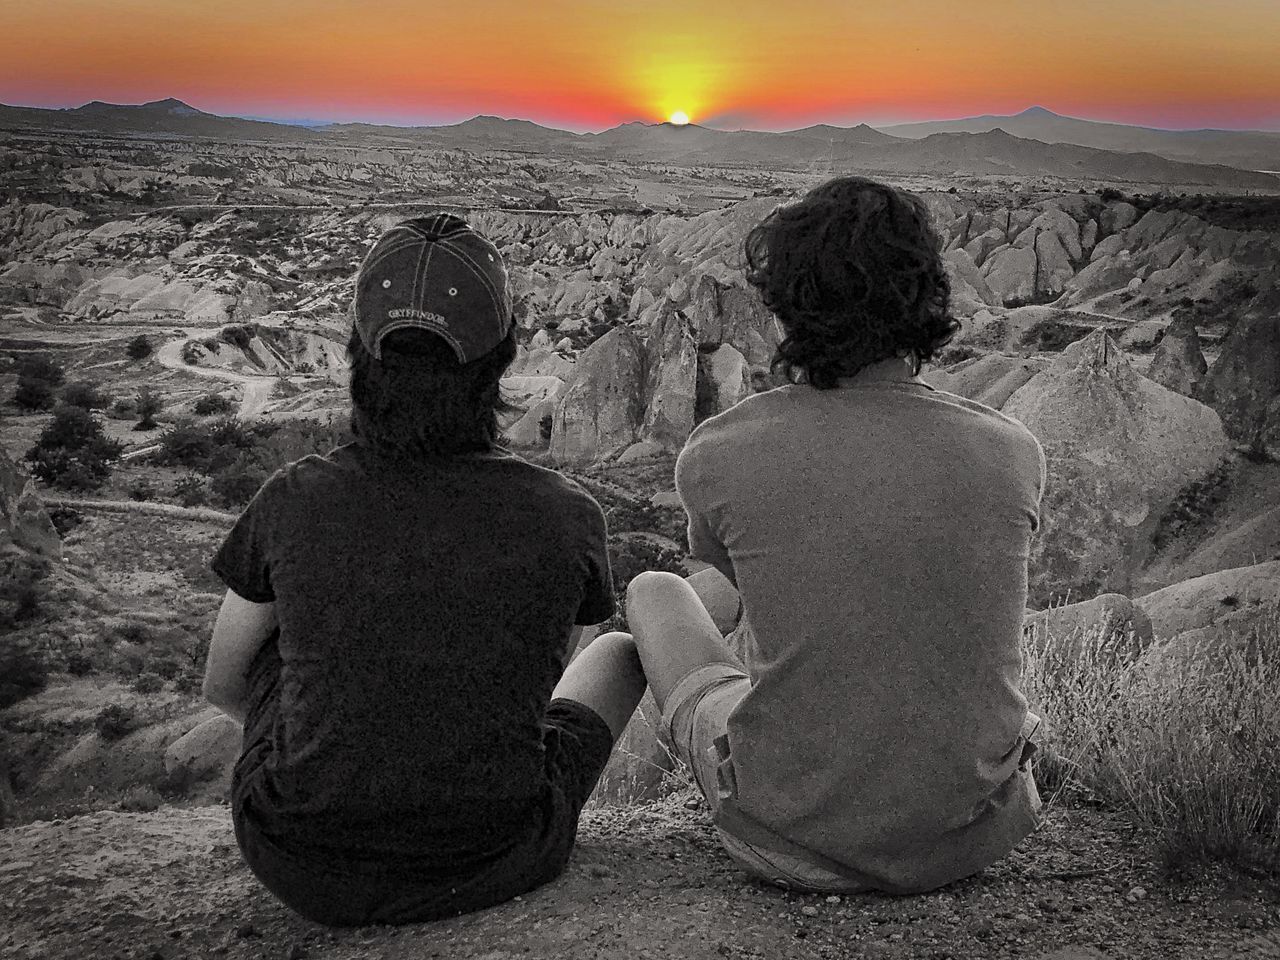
left=640, top=310, right=698, bottom=451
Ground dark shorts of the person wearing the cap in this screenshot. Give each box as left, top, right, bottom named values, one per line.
left=232, top=644, right=613, bottom=927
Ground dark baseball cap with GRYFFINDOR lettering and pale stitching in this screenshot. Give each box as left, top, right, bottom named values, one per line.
left=352, top=214, right=513, bottom=364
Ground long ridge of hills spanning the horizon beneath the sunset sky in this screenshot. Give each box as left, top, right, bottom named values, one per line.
left=0, top=97, right=1280, bottom=191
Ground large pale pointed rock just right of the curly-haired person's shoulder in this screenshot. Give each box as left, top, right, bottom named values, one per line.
left=1004, top=330, right=1230, bottom=600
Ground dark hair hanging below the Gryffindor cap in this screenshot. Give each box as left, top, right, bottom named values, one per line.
left=347, top=324, right=516, bottom=460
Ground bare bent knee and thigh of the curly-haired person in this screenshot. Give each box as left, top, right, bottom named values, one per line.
left=627, top=571, right=739, bottom=710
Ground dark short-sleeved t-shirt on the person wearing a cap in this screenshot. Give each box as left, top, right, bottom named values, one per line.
left=212, top=443, right=614, bottom=865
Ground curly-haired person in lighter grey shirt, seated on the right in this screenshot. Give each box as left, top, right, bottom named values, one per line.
left=627, top=177, right=1044, bottom=893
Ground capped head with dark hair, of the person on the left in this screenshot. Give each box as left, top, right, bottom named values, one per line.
left=347, top=214, right=516, bottom=458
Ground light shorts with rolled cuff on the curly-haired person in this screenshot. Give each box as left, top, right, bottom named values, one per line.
left=660, top=660, right=868, bottom=893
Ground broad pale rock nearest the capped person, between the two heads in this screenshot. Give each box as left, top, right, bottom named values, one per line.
left=550, top=326, right=644, bottom=465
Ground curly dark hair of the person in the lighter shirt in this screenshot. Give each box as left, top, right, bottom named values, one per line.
left=745, top=177, right=960, bottom=390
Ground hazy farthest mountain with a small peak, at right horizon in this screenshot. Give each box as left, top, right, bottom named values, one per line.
left=882, top=106, right=1280, bottom=170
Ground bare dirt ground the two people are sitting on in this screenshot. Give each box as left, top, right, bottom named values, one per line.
left=0, top=794, right=1280, bottom=960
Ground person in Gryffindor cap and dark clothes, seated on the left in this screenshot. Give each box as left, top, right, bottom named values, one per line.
left=205, top=214, right=645, bottom=925
